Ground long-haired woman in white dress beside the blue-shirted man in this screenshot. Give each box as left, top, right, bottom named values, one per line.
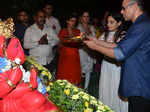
left=99, top=13, right=128, bottom=112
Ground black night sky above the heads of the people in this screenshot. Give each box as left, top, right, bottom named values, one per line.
left=0, top=0, right=148, bottom=22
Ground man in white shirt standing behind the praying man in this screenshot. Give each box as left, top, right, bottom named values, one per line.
left=43, top=3, right=61, bottom=34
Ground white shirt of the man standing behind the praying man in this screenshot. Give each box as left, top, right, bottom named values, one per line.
left=45, top=16, right=61, bottom=34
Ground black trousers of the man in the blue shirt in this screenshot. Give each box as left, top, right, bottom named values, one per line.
left=128, top=96, right=150, bottom=112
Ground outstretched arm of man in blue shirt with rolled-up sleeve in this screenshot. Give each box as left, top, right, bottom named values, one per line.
left=84, top=25, right=150, bottom=61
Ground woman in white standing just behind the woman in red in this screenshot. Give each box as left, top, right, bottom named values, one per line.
left=77, top=11, right=96, bottom=89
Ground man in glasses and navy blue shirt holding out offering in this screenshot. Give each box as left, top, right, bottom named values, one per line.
left=84, top=0, right=150, bottom=112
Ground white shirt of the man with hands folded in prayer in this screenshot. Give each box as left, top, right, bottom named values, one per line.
left=24, top=24, right=59, bottom=65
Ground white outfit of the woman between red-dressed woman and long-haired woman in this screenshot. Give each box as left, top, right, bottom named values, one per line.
left=77, top=24, right=96, bottom=89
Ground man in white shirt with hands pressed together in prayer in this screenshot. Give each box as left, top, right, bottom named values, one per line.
left=24, top=10, right=59, bottom=65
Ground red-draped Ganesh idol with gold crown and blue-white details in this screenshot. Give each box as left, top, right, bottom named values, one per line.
left=0, top=19, right=57, bottom=112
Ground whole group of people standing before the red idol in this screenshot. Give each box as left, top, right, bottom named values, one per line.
left=4, top=0, right=150, bottom=112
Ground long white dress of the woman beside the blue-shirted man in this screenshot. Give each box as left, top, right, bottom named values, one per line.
left=99, top=32, right=128, bottom=112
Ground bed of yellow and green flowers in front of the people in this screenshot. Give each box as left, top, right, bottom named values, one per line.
left=47, top=80, right=113, bottom=112
